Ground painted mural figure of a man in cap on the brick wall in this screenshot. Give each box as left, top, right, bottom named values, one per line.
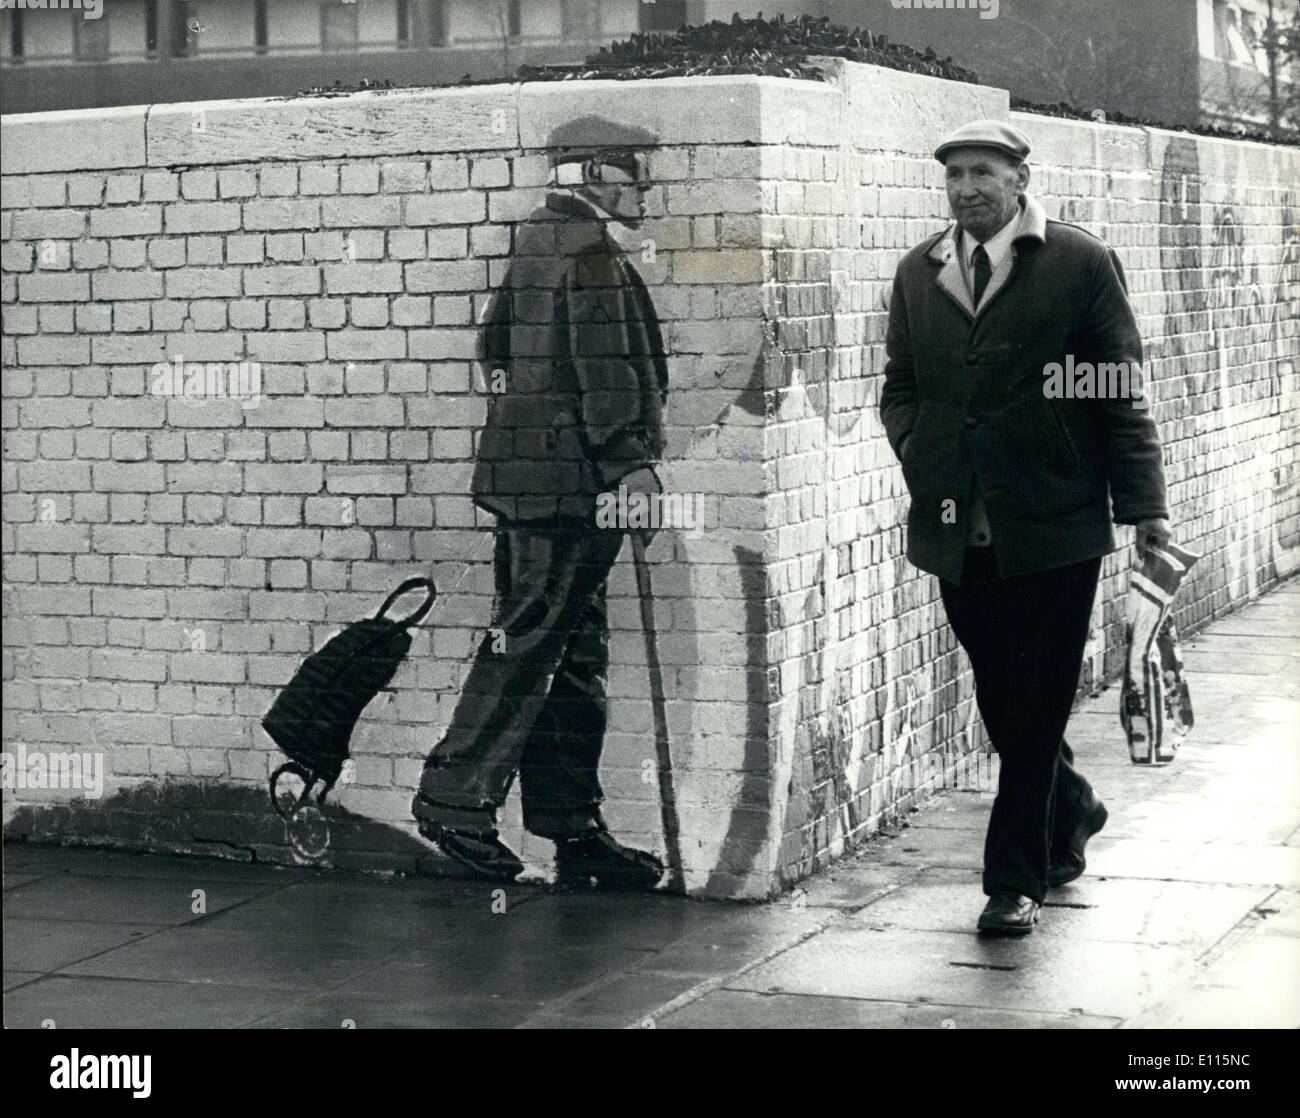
left=412, top=117, right=668, bottom=889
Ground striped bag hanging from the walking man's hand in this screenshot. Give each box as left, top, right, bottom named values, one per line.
left=1119, top=543, right=1201, bottom=764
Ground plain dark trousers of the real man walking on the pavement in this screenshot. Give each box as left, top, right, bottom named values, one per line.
left=940, top=547, right=1101, bottom=904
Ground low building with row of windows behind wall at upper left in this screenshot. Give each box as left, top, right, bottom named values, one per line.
left=0, top=0, right=686, bottom=113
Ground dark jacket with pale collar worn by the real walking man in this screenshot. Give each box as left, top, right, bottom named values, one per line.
left=880, top=189, right=1169, bottom=582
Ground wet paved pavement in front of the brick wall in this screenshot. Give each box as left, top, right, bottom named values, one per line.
left=4, top=581, right=1300, bottom=1028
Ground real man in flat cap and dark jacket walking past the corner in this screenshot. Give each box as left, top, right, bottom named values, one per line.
left=880, top=121, right=1169, bottom=935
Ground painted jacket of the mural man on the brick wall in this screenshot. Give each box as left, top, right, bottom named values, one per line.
left=471, top=194, right=668, bottom=524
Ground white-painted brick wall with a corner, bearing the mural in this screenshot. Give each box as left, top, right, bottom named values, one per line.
left=0, top=64, right=1300, bottom=896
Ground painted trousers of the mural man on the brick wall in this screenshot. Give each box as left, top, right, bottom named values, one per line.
left=415, top=525, right=623, bottom=839
